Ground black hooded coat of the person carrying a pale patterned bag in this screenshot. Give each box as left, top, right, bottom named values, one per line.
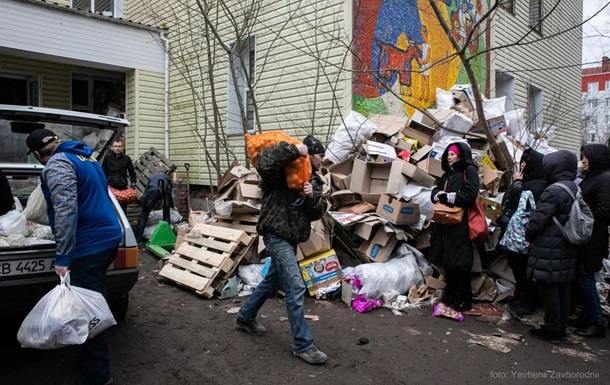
left=502, top=148, right=546, bottom=212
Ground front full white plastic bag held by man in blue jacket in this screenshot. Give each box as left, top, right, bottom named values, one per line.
left=17, top=274, right=89, bottom=349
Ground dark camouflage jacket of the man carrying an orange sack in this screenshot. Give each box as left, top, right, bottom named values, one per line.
left=256, top=142, right=326, bottom=246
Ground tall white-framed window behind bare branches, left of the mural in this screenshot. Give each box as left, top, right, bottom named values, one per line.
left=227, top=36, right=256, bottom=135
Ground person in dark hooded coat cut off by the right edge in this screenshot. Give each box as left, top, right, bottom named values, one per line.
left=570, top=144, right=610, bottom=337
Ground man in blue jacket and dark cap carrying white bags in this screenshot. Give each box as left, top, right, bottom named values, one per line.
left=26, top=129, right=123, bottom=385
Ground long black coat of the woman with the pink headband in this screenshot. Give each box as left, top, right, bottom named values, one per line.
left=429, top=142, right=479, bottom=270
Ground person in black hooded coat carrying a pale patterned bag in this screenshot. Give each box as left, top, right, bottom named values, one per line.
left=502, top=148, right=546, bottom=318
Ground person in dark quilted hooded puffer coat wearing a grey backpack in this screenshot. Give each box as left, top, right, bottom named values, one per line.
left=525, top=150, right=578, bottom=344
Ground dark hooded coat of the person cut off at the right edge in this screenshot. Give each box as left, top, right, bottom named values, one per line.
left=580, top=144, right=610, bottom=274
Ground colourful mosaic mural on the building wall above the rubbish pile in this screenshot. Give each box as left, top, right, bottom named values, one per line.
left=353, top=0, right=489, bottom=116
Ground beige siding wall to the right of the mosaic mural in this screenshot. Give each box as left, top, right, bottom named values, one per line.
left=490, top=0, right=582, bottom=150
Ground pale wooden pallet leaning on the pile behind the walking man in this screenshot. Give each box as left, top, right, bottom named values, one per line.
left=159, top=223, right=253, bottom=298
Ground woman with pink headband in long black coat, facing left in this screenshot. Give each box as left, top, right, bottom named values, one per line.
left=430, top=142, right=479, bottom=311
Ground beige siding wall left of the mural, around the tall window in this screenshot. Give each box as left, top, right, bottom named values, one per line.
left=126, top=0, right=351, bottom=185
